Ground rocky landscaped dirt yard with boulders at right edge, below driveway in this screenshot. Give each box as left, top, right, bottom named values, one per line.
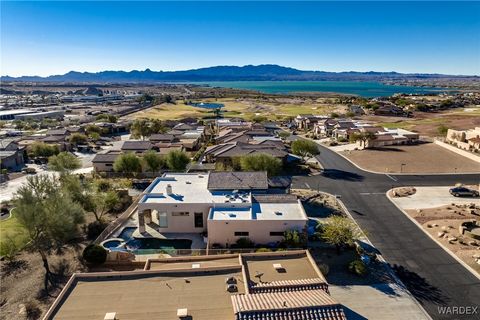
left=406, top=204, right=480, bottom=274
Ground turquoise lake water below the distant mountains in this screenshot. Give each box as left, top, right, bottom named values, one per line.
left=191, top=81, right=449, bottom=98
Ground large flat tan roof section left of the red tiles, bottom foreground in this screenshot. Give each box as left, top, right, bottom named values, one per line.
left=53, top=269, right=244, bottom=320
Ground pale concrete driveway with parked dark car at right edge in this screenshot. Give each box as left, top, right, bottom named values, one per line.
left=392, top=187, right=480, bottom=209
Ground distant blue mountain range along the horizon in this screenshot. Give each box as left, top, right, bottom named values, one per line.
left=0, top=64, right=480, bottom=83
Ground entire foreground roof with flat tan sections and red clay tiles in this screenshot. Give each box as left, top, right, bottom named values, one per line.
left=45, top=250, right=344, bottom=320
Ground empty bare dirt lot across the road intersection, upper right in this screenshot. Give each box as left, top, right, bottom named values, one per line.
left=341, top=143, right=480, bottom=173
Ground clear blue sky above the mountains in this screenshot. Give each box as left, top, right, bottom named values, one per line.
left=0, top=1, right=480, bottom=76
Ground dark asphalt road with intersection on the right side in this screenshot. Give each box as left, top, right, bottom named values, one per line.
left=293, top=146, right=480, bottom=319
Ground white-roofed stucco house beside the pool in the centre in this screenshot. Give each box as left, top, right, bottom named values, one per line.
left=138, top=172, right=308, bottom=247
